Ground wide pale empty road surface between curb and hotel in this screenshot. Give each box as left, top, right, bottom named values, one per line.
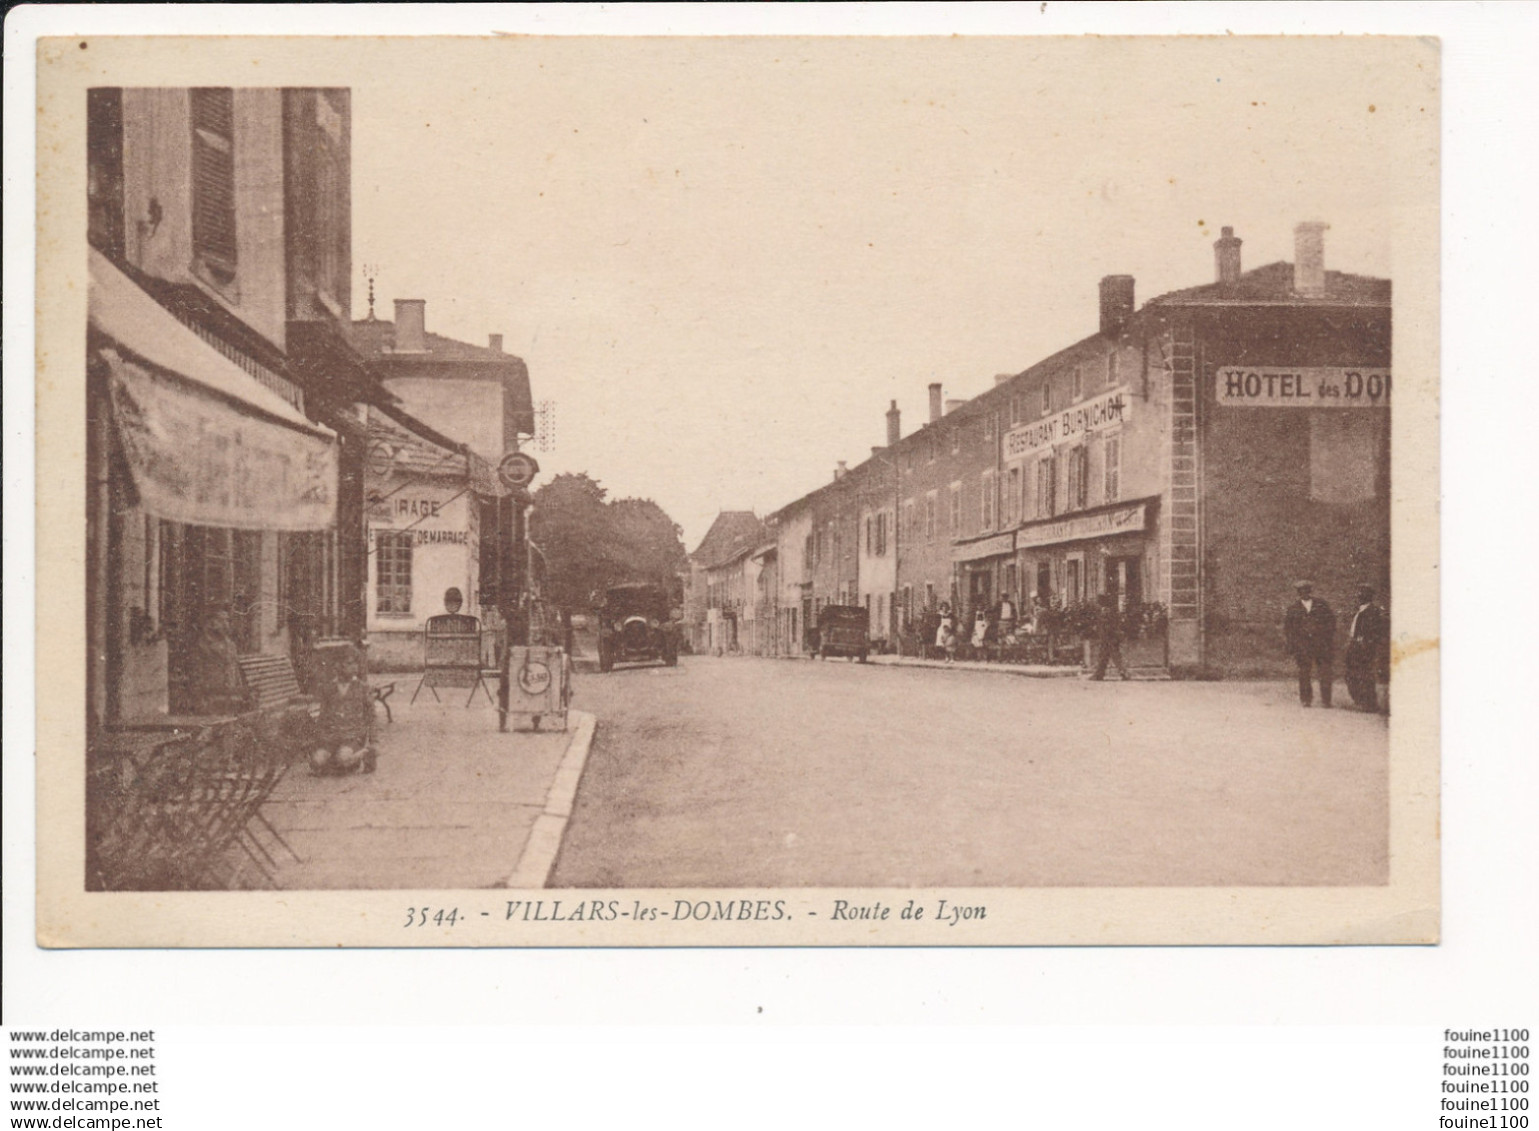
left=553, top=657, right=1388, bottom=888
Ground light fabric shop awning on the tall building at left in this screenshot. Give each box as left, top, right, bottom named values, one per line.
left=88, top=251, right=337, bottom=531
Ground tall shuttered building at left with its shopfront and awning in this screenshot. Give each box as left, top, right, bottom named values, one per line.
left=86, top=88, right=380, bottom=732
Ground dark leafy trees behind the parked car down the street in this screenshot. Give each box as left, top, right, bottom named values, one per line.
left=529, top=472, right=685, bottom=609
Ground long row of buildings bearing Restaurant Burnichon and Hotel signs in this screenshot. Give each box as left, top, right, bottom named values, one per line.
left=768, top=223, right=1391, bottom=674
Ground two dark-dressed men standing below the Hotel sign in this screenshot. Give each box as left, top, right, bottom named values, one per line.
left=1282, top=582, right=1390, bottom=711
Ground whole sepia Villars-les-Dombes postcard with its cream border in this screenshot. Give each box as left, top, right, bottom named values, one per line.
left=37, top=35, right=1441, bottom=948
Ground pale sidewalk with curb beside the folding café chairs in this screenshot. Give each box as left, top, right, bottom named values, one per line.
left=263, top=689, right=596, bottom=889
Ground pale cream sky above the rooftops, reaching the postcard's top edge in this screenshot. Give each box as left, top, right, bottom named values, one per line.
left=336, top=38, right=1436, bottom=549
